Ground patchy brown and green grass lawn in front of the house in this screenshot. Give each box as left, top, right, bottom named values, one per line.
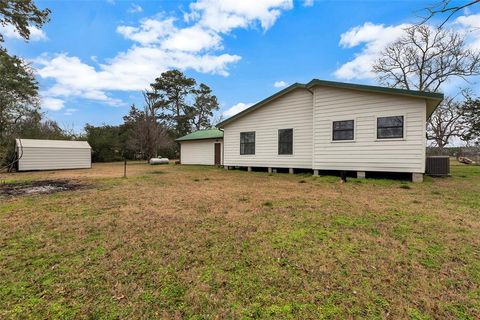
left=0, top=163, right=480, bottom=319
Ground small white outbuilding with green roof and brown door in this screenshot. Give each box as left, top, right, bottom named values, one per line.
left=176, top=129, right=223, bottom=165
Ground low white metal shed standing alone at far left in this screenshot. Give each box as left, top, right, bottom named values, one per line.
left=16, top=139, right=92, bottom=171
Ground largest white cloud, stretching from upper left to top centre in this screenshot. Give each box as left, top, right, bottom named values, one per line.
left=34, top=0, right=293, bottom=105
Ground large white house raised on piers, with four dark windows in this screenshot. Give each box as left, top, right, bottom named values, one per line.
left=217, top=79, right=443, bottom=181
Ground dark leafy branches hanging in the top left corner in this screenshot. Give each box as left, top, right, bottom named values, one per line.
left=0, top=0, right=51, bottom=42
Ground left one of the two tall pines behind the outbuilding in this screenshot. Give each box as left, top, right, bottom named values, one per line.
left=146, top=70, right=196, bottom=137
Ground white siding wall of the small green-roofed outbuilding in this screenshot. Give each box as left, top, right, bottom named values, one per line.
left=180, top=139, right=223, bottom=165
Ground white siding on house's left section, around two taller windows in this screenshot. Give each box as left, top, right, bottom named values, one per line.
left=223, top=89, right=313, bottom=168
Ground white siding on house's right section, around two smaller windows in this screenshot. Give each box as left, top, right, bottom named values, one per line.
left=313, top=86, right=426, bottom=173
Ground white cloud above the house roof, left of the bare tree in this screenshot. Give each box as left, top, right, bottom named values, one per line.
left=335, top=22, right=408, bottom=80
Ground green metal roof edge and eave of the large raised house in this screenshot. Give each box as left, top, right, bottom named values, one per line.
left=217, top=79, right=443, bottom=128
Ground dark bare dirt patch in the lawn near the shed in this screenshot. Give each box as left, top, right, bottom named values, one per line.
left=0, top=180, right=85, bottom=196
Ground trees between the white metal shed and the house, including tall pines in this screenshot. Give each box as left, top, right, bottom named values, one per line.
left=84, top=70, right=219, bottom=161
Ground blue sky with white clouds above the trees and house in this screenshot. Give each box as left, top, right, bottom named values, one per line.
left=3, top=0, right=480, bottom=131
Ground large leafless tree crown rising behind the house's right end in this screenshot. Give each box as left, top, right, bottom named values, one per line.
left=373, top=25, right=480, bottom=92
